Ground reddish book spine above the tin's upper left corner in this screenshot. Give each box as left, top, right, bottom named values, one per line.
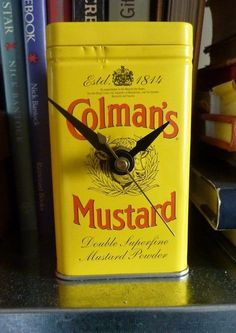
left=47, top=0, right=72, bottom=23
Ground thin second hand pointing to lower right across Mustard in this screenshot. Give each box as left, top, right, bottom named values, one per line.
left=98, top=132, right=175, bottom=236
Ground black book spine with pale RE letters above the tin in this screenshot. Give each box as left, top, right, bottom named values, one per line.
left=72, top=0, right=106, bottom=22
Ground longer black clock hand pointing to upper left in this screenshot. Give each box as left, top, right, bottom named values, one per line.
left=48, top=98, right=112, bottom=156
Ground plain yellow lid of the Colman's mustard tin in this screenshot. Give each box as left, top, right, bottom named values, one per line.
left=47, top=22, right=192, bottom=47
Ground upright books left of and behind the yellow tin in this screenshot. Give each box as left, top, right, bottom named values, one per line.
left=0, top=0, right=205, bottom=241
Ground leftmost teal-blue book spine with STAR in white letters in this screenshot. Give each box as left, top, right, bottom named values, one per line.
left=0, top=0, right=37, bottom=231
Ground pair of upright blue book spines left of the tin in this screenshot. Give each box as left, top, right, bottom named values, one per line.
left=0, top=0, right=53, bottom=239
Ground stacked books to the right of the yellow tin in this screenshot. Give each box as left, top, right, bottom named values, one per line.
left=190, top=0, right=236, bottom=246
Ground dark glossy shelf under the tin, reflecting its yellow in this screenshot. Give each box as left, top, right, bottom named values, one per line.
left=0, top=202, right=236, bottom=332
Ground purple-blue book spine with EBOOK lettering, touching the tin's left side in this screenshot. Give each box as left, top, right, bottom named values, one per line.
left=22, top=0, right=53, bottom=234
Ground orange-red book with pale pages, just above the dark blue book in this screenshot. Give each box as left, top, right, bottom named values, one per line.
left=201, top=114, right=236, bottom=152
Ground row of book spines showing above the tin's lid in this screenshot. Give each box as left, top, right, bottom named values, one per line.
left=48, top=0, right=205, bottom=26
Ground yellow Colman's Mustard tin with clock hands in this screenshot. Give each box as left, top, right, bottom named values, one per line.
left=47, top=22, right=192, bottom=279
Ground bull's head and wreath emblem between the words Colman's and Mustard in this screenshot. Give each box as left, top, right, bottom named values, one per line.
left=87, top=138, right=159, bottom=196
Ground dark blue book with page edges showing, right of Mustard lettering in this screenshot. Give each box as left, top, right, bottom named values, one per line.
left=190, top=158, right=236, bottom=230
